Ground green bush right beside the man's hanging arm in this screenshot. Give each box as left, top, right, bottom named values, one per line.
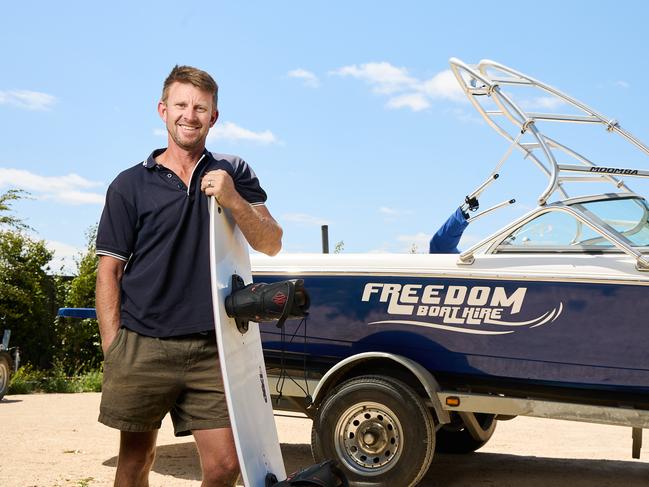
left=54, top=226, right=102, bottom=374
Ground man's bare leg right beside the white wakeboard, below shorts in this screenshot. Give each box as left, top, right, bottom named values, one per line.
left=192, top=428, right=239, bottom=487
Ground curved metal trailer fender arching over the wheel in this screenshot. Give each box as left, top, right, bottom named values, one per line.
left=311, top=352, right=451, bottom=424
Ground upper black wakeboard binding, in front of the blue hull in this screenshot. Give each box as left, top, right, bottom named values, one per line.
left=225, top=274, right=311, bottom=333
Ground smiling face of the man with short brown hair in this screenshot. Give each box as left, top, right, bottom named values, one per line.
left=158, top=82, right=219, bottom=151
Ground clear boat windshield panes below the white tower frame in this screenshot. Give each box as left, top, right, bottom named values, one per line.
left=498, top=197, right=649, bottom=251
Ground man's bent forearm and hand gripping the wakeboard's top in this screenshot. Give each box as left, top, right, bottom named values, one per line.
left=201, top=170, right=283, bottom=255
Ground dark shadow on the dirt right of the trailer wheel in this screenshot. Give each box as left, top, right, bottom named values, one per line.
left=420, top=452, right=649, bottom=487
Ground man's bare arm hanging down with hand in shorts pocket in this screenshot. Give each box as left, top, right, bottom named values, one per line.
left=95, top=255, right=126, bottom=355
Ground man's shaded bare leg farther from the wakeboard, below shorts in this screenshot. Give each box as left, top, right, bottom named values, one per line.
left=115, top=430, right=158, bottom=487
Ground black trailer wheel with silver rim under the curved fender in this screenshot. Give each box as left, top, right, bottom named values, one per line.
left=311, top=375, right=435, bottom=487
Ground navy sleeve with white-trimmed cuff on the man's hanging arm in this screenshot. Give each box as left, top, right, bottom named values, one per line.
left=97, top=182, right=137, bottom=261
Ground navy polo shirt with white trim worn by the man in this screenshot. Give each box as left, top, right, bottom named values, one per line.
left=97, top=149, right=266, bottom=337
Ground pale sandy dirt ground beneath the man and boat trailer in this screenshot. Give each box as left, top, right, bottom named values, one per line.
left=0, top=393, right=649, bottom=487
